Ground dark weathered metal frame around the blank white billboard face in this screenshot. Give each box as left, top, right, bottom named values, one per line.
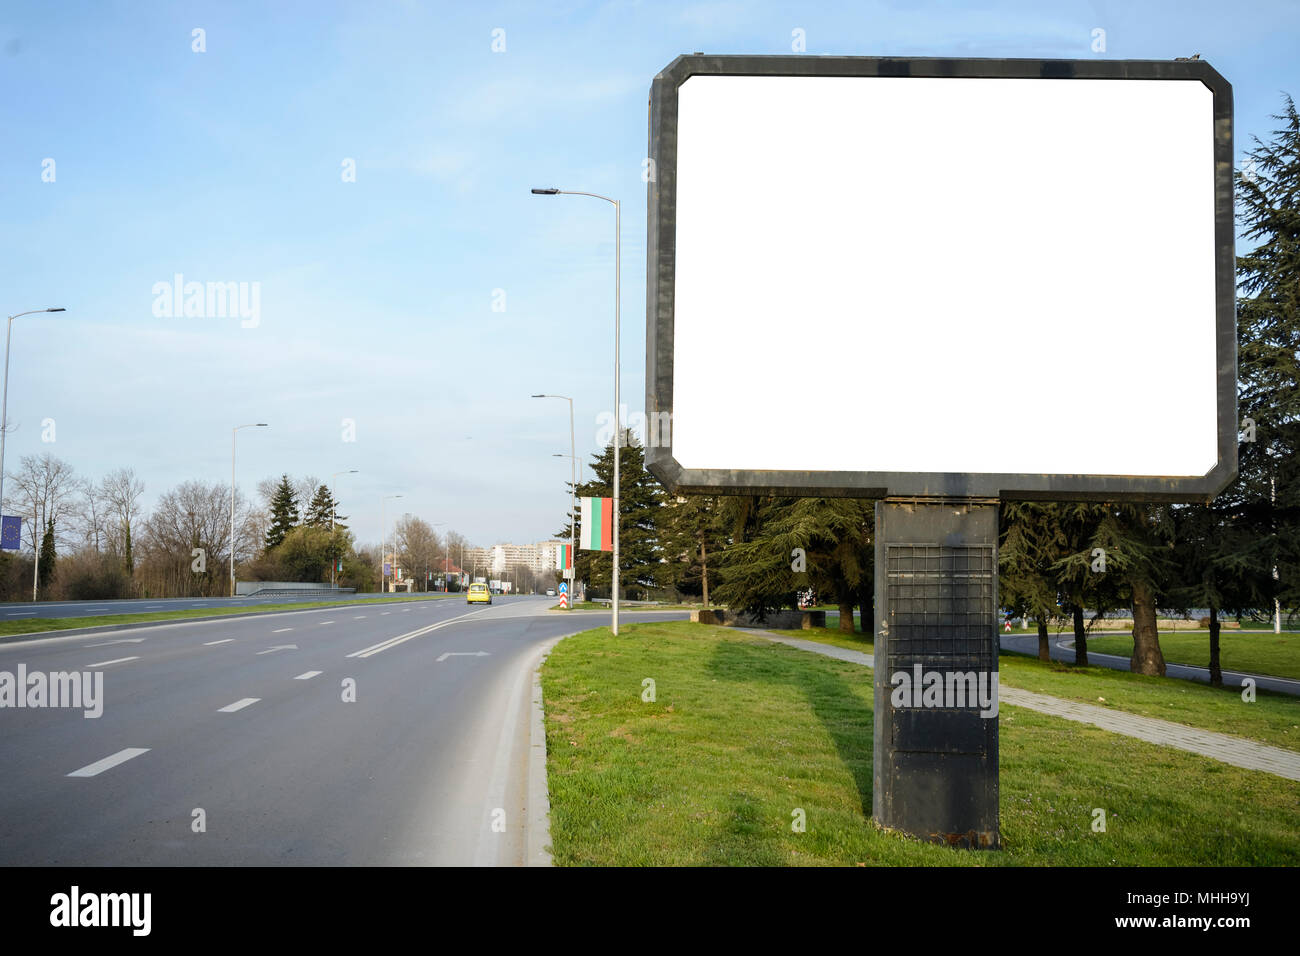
left=646, top=53, right=1238, bottom=502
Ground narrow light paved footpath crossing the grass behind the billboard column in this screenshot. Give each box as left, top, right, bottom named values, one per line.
left=751, top=631, right=1300, bottom=780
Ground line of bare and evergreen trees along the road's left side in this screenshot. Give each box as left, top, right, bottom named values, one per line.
left=0, top=463, right=483, bottom=601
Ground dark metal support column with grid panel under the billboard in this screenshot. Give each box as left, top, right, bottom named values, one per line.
left=871, top=498, right=1001, bottom=849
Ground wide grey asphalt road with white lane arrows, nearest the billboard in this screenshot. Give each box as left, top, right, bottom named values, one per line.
left=0, top=597, right=686, bottom=866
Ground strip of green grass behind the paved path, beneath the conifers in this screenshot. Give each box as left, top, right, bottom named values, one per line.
left=774, top=630, right=1300, bottom=750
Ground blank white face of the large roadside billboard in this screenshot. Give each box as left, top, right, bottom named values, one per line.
left=672, top=75, right=1218, bottom=476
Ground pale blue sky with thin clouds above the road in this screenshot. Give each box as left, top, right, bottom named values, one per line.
left=0, top=0, right=1300, bottom=544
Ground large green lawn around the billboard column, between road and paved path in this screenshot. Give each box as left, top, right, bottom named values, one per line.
left=542, top=622, right=1300, bottom=866
